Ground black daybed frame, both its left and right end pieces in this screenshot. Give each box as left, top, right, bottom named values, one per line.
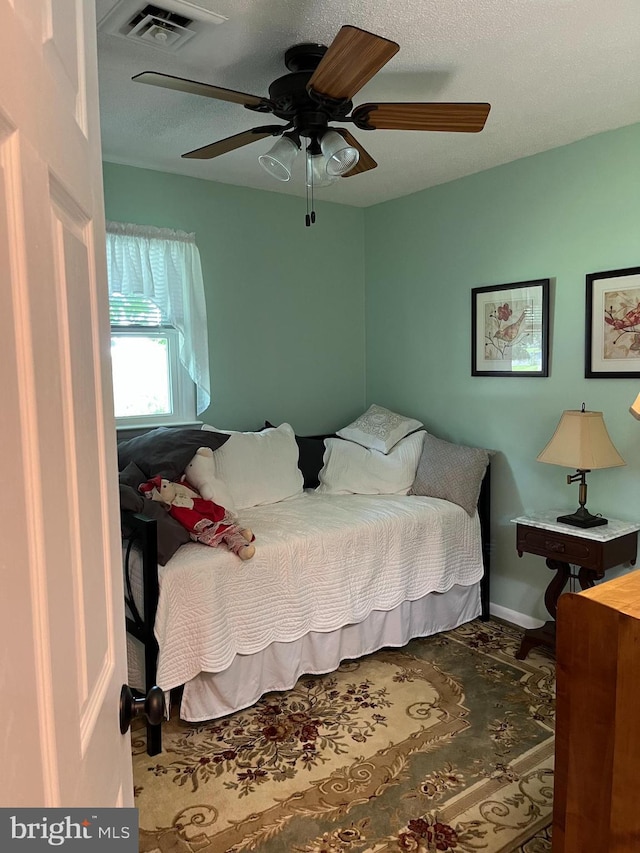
left=121, top=466, right=491, bottom=755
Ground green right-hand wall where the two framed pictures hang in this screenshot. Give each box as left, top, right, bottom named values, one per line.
left=365, top=125, right=640, bottom=617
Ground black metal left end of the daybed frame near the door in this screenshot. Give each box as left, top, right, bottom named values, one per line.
left=122, top=512, right=162, bottom=755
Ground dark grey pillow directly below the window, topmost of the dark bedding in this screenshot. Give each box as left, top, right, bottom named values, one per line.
left=118, top=427, right=229, bottom=481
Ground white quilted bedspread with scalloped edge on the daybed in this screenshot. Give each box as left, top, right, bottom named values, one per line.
left=145, top=492, right=483, bottom=690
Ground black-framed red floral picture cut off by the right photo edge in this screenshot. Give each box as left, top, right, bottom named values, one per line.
left=584, top=267, right=640, bottom=379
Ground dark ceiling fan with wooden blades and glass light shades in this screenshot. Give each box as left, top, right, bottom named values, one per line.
left=133, top=25, right=490, bottom=224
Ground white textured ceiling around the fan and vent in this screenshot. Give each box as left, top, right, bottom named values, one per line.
left=96, top=0, right=640, bottom=206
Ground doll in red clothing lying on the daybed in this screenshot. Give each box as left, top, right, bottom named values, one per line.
left=138, top=477, right=256, bottom=560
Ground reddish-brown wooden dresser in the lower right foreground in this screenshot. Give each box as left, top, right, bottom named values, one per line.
left=553, top=571, right=640, bottom=853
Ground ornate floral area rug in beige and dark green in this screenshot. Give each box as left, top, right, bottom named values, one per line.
left=133, top=621, right=555, bottom=853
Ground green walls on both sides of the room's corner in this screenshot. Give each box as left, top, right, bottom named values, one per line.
left=104, top=125, right=640, bottom=618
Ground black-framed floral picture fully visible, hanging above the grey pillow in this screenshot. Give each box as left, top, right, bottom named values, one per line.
left=471, top=278, right=551, bottom=377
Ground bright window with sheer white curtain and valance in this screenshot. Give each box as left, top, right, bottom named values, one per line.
left=107, top=223, right=210, bottom=426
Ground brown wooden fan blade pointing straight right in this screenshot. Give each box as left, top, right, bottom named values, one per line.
left=351, top=104, right=491, bottom=133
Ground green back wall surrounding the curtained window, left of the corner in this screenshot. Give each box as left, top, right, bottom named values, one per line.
left=104, top=163, right=365, bottom=433
